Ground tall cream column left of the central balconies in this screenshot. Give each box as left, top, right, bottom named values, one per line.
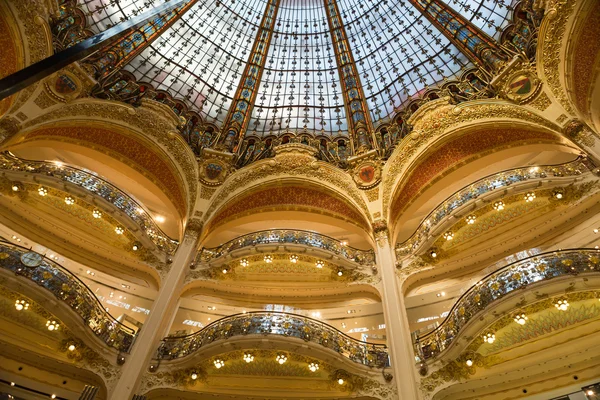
left=109, top=220, right=201, bottom=400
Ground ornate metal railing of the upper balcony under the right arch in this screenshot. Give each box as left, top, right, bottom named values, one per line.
left=396, top=157, right=593, bottom=258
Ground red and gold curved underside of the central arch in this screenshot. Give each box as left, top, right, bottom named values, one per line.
left=205, top=178, right=371, bottom=237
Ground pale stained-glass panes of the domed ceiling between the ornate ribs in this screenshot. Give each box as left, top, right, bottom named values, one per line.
left=78, top=0, right=510, bottom=137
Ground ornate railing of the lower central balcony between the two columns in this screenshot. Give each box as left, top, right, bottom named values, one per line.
left=157, top=311, right=389, bottom=368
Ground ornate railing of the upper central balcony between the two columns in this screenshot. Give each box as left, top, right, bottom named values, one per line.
left=197, top=229, right=375, bottom=266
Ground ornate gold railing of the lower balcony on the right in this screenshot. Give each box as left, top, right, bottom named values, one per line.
left=416, top=249, right=600, bottom=359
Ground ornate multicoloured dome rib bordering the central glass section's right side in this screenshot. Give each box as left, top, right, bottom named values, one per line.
left=325, top=0, right=377, bottom=155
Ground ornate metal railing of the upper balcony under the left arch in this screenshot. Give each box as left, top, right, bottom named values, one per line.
left=0, top=152, right=179, bottom=254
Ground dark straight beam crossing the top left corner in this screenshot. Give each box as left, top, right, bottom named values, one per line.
left=0, top=0, right=189, bottom=100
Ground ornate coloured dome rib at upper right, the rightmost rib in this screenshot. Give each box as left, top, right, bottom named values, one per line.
left=409, top=0, right=507, bottom=72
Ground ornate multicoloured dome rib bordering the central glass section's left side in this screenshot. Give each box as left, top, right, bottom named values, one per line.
left=217, top=0, right=280, bottom=153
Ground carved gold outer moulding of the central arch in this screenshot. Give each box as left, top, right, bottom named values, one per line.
left=205, top=151, right=370, bottom=227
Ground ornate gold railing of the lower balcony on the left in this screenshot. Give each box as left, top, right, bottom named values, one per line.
left=0, top=241, right=136, bottom=352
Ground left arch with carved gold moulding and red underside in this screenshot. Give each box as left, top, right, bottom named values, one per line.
left=4, top=99, right=198, bottom=218
